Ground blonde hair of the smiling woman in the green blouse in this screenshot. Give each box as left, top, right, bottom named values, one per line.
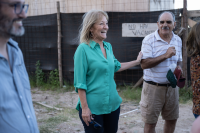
left=79, top=10, right=108, bottom=45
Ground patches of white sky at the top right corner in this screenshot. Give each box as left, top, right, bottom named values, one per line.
left=175, top=0, right=200, bottom=10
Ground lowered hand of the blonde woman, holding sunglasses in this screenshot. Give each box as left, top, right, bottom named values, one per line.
left=82, top=107, right=93, bottom=126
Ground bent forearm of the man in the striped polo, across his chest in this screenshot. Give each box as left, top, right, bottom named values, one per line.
left=141, top=54, right=167, bottom=69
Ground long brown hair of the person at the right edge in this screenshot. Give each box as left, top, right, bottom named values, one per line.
left=186, top=22, right=200, bottom=57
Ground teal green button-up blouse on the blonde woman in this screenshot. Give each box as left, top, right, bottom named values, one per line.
left=74, top=41, right=122, bottom=115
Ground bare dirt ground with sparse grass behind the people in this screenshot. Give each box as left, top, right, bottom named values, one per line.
left=31, top=88, right=195, bottom=133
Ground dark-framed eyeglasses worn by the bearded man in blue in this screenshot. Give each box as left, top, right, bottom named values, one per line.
left=0, top=2, right=29, bottom=15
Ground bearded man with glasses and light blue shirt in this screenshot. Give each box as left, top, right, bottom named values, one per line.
left=0, top=0, right=39, bottom=133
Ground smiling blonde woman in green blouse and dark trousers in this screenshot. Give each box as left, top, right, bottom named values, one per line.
left=74, top=10, right=142, bottom=133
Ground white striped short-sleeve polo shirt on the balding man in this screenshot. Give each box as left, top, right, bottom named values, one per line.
left=142, top=30, right=182, bottom=84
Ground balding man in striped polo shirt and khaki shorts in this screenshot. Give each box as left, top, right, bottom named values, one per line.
left=140, top=11, right=182, bottom=133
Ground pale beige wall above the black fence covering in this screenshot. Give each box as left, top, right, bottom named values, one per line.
left=25, top=0, right=174, bottom=16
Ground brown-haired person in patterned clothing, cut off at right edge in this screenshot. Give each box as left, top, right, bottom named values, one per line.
left=186, top=22, right=200, bottom=118
